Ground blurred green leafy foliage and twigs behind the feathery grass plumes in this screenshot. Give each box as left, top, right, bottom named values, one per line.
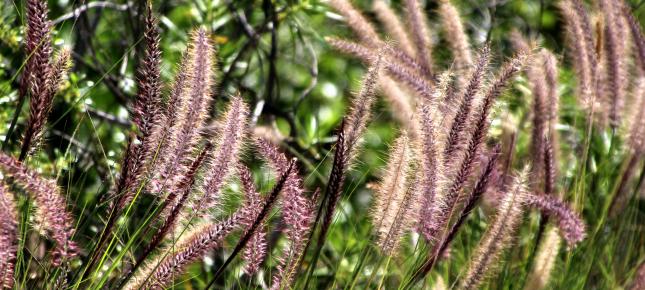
left=0, top=0, right=645, bottom=288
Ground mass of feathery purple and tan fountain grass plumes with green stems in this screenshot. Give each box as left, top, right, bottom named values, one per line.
left=0, top=0, right=645, bottom=289
